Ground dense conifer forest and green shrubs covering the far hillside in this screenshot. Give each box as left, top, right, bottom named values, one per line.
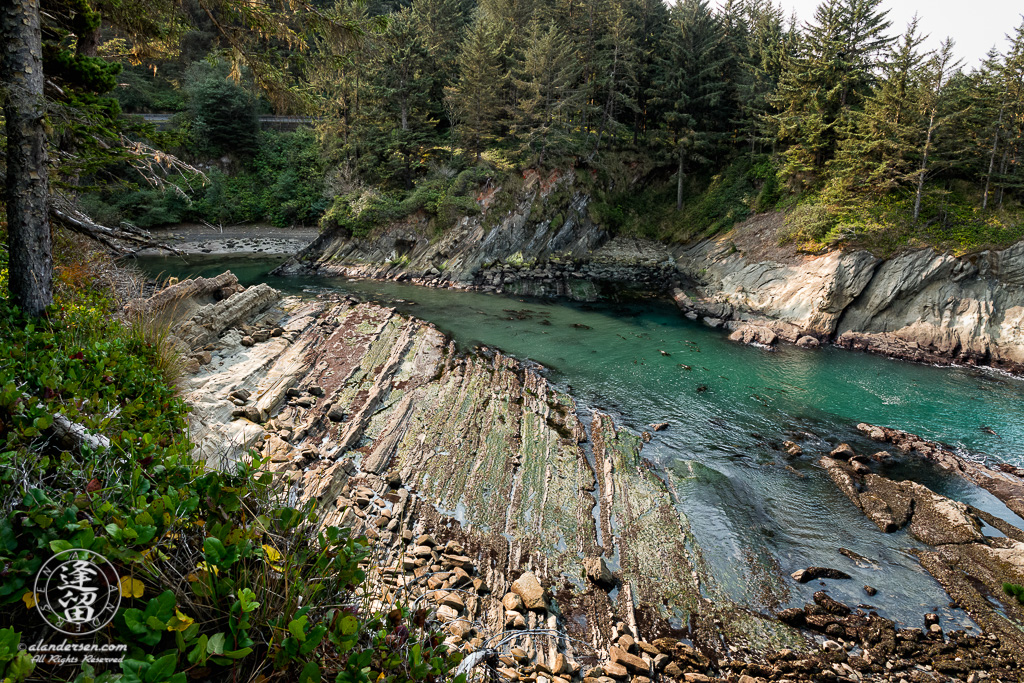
left=34, top=0, right=1024, bottom=259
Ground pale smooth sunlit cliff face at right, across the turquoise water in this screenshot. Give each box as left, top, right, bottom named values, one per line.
left=675, top=218, right=1024, bottom=372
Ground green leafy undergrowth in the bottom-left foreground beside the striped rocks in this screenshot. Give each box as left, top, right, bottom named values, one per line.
left=0, top=236, right=461, bottom=683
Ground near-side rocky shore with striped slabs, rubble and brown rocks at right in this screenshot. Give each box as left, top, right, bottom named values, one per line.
left=125, top=273, right=1024, bottom=683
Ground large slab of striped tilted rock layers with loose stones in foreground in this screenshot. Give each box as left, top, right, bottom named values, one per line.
left=146, top=274, right=1024, bottom=683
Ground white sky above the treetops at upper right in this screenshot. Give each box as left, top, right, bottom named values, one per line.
left=776, top=0, right=1024, bottom=69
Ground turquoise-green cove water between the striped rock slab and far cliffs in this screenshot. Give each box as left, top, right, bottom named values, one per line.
left=138, top=253, right=1024, bottom=626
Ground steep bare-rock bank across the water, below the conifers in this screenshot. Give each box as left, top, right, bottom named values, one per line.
left=282, top=171, right=1024, bottom=372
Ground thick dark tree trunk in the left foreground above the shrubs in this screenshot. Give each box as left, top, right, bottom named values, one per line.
left=0, top=0, right=53, bottom=315
